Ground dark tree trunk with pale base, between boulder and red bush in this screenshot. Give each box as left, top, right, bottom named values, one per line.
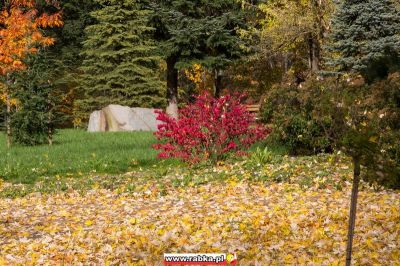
left=167, top=57, right=178, bottom=119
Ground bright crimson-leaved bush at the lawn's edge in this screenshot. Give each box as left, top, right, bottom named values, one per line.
left=154, top=93, right=270, bottom=163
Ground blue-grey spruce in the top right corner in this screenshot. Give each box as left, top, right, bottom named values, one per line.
left=330, top=0, right=400, bottom=82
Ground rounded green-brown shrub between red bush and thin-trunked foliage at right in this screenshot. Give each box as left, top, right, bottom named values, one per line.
left=261, top=80, right=332, bottom=155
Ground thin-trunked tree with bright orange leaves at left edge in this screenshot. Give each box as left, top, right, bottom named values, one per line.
left=0, top=0, right=63, bottom=146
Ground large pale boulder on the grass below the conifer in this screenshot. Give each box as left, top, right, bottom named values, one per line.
left=88, top=105, right=160, bottom=132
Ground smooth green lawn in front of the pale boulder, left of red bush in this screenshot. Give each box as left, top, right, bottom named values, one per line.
left=0, top=130, right=157, bottom=184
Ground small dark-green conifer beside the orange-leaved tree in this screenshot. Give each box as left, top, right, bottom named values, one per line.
left=11, top=50, right=64, bottom=145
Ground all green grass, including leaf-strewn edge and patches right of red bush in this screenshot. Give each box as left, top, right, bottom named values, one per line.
left=0, top=129, right=286, bottom=192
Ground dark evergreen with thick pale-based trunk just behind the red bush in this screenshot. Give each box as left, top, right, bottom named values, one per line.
left=152, top=0, right=208, bottom=118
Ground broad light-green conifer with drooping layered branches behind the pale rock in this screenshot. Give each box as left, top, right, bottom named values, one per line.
left=77, top=0, right=164, bottom=119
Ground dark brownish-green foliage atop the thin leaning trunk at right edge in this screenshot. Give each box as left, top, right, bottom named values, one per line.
left=313, top=73, right=400, bottom=188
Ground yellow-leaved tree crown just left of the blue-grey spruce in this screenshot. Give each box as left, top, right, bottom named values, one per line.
left=260, top=0, right=334, bottom=70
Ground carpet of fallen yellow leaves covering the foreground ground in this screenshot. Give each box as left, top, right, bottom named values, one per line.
left=0, top=156, right=400, bottom=265
